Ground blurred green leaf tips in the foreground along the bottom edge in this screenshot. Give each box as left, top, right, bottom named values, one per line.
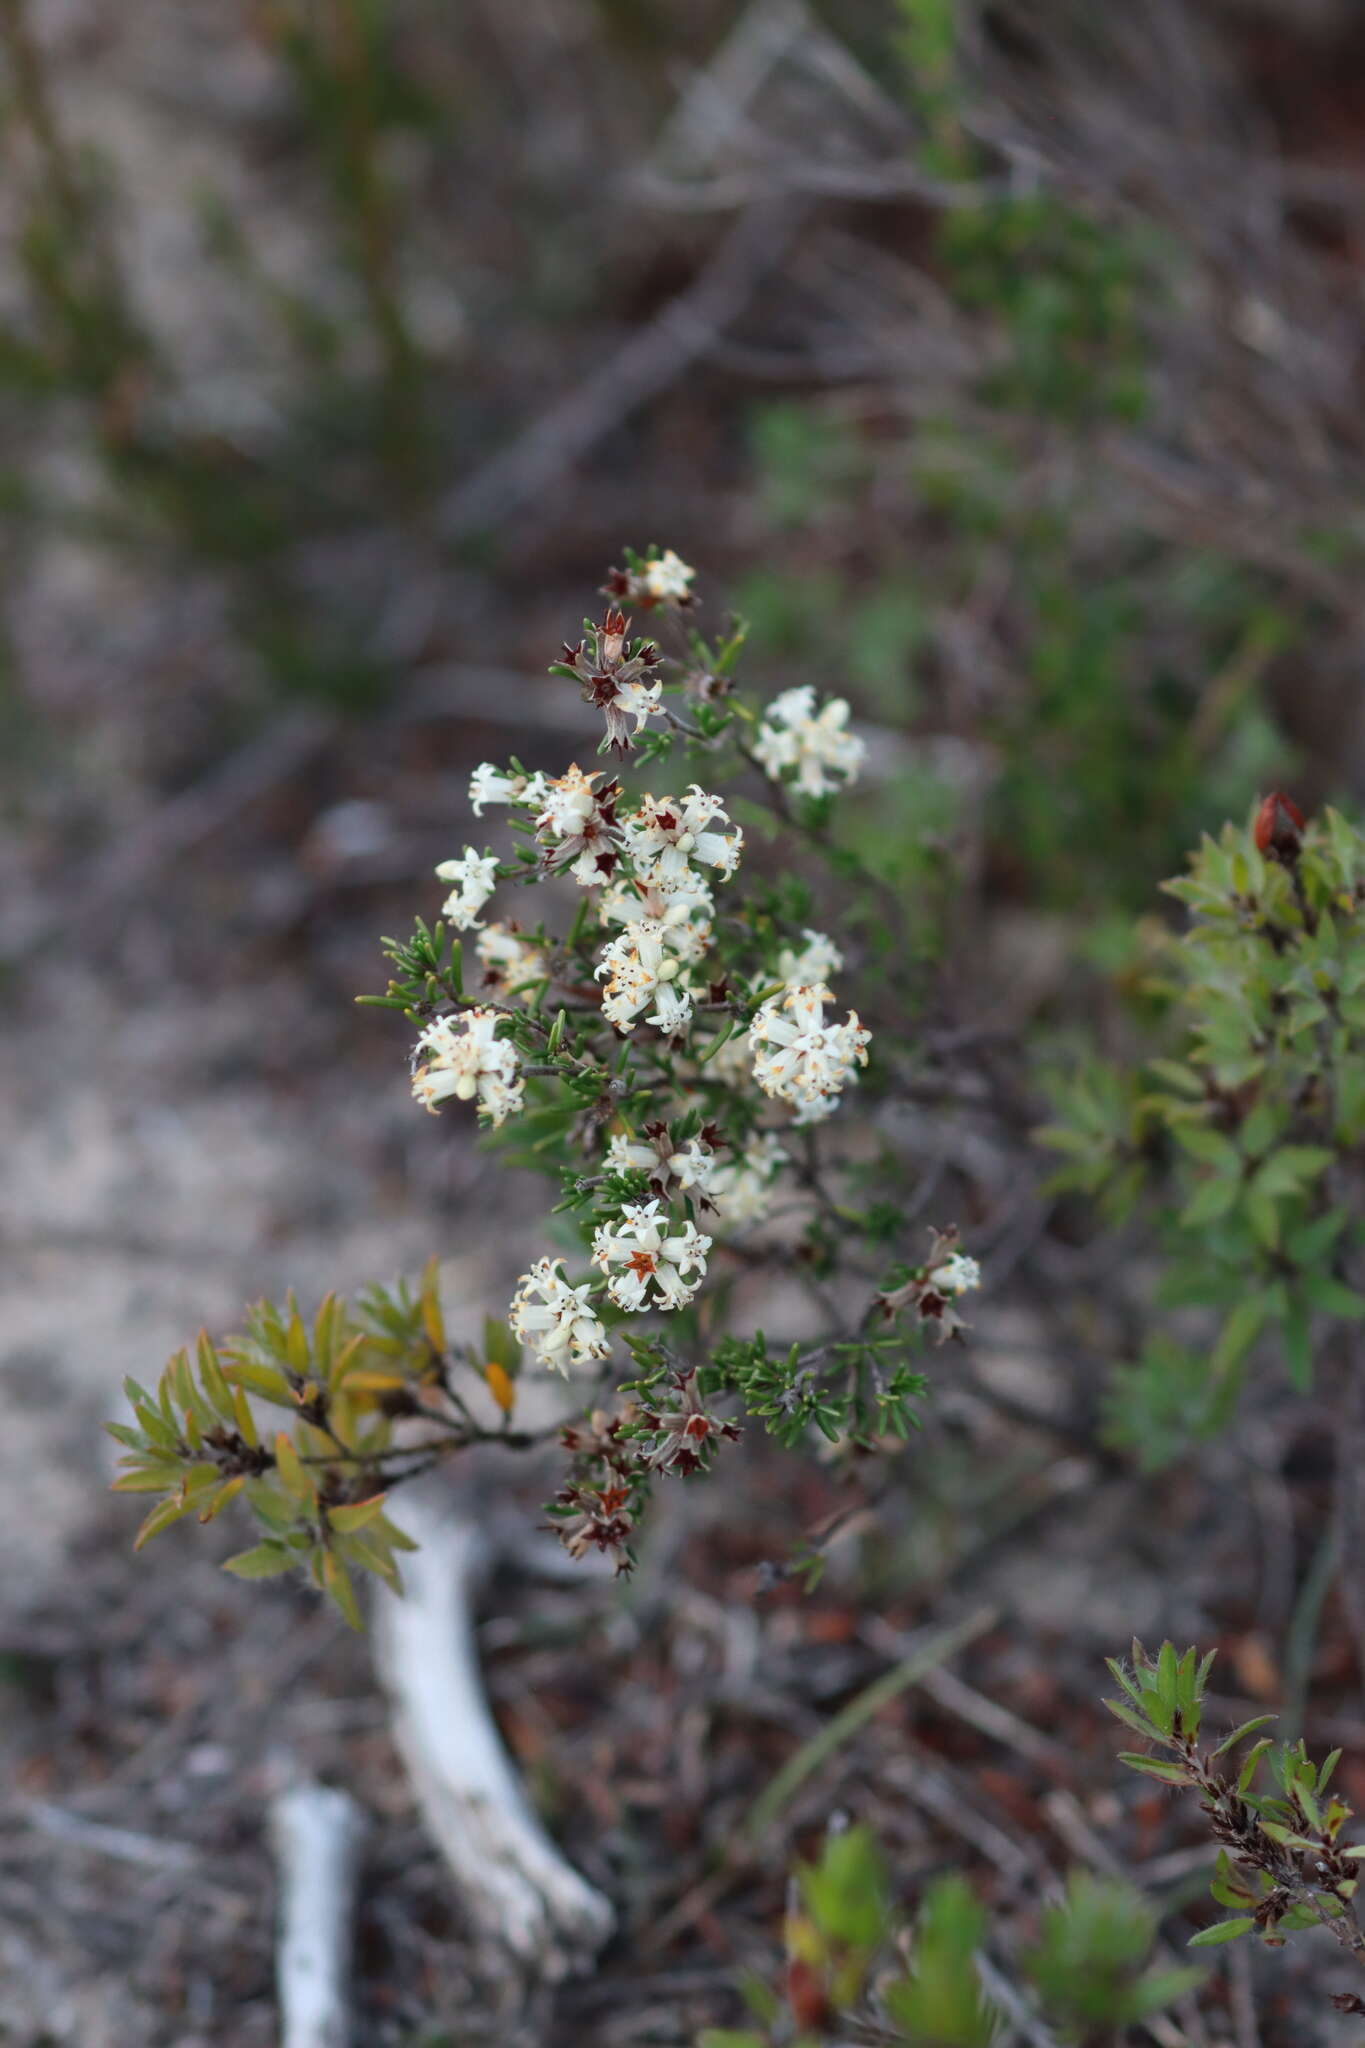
left=698, top=1827, right=1199, bottom=2048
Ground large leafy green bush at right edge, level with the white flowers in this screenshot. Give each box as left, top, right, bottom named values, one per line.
left=1038, top=811, right=1365, bottom=1468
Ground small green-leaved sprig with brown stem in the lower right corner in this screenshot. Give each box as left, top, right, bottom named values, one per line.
left=1105, top=1642, right=1365, bottom=1958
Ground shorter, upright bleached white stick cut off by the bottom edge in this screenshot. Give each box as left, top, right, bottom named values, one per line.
left=270, top=1780, right=364, bottom=2048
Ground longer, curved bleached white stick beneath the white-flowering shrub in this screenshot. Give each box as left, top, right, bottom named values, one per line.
left=375, top=1485, right=614, bottom=1976
